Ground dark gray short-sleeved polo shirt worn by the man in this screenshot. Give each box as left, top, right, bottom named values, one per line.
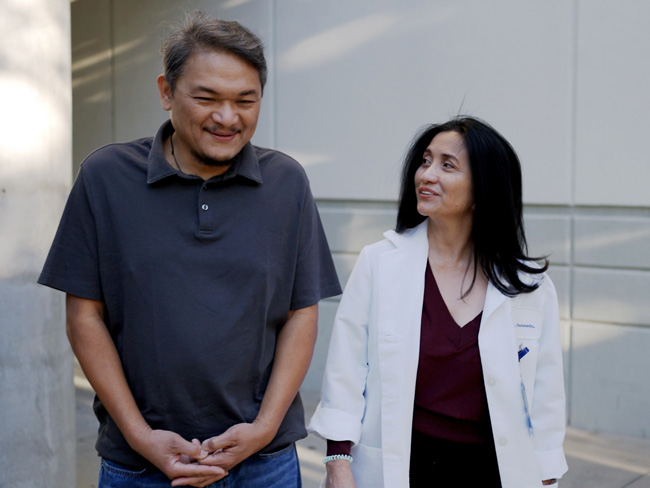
left=39, top=122, right=341, bottom=466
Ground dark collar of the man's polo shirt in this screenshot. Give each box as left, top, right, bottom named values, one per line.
left=147, top=120, right=262, bottom=184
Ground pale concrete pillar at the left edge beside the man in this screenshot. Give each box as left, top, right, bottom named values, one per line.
left=0, top=0, right=75, bottom=488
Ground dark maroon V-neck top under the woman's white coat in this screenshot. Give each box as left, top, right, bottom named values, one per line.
left=413, top=263, right=492, bottom=443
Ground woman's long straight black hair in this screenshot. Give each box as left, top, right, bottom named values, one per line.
left=395, top=117, right=548, bottom=296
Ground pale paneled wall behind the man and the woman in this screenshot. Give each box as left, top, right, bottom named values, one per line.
left=72, top=0, right=650, bottom=437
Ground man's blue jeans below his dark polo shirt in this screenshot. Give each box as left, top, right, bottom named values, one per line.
left=98, top=444, right=302, bottom=488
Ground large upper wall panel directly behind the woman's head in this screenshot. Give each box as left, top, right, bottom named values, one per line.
left=275, top=0, right=573, bottom=204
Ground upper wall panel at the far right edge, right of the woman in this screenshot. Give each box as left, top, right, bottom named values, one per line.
left=574, top=0, right=650, bottom=207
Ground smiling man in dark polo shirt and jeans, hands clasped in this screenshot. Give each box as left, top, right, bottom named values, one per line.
left=39, top=13, right=340, bottom=488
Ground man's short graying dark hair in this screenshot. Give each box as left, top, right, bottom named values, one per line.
left=161, top=11, right=267, bottom=93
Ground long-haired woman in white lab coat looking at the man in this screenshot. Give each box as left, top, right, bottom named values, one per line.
left=309, top=117, right=567, bottom=488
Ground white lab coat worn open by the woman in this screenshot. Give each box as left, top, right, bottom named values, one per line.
left=309, top=221, right=567, bottom=488
